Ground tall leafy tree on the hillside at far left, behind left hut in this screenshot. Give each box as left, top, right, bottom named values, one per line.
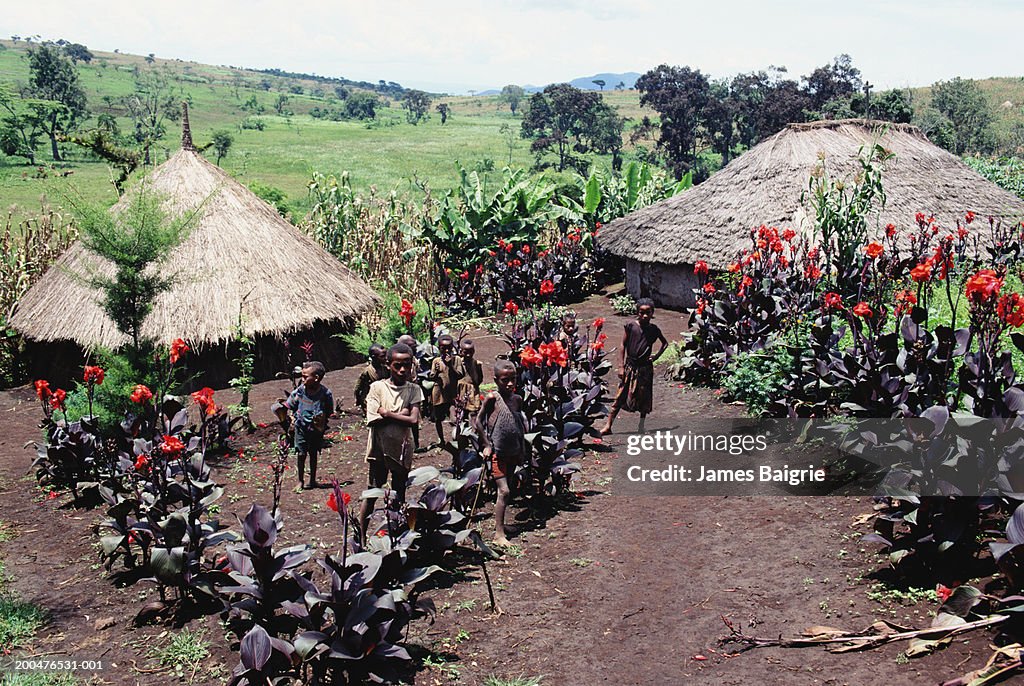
left=29, top=44, right=86, bottom=162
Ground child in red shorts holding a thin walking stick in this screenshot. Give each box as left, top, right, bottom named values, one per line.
left=474, top=359, right=526, bottom=546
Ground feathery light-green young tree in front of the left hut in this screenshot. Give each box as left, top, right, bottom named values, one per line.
left=76, top=181, right=196, bottom=363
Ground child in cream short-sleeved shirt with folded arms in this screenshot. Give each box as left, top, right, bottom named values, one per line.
left=359, top=343, right=423, bottom=539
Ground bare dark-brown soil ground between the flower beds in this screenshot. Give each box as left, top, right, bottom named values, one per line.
left=0, top=297, right=991, bottom=686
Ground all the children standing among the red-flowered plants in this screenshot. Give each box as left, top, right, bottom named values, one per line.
left=273, top=300, right=667, bottom=545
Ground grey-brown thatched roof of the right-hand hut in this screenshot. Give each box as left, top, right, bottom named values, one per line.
left=599, top=120, right=1024, bottom=269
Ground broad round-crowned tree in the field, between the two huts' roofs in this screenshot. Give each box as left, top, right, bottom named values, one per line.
left=520, top=83, right=623, bottom=173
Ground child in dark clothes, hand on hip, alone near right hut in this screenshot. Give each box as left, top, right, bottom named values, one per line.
left=601, top=298, right=669, bottom=434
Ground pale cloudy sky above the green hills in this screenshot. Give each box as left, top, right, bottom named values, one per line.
left=0, top=0, right=1024, bottom=93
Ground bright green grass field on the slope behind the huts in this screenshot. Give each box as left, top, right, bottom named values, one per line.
left=0, top=41, right=654, bottom=223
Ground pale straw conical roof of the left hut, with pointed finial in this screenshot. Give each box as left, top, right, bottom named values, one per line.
left=11, top=149, right=379, bottom=348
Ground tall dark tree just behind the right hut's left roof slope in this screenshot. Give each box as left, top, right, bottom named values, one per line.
left=636, top=65, right=711, bottom=178
